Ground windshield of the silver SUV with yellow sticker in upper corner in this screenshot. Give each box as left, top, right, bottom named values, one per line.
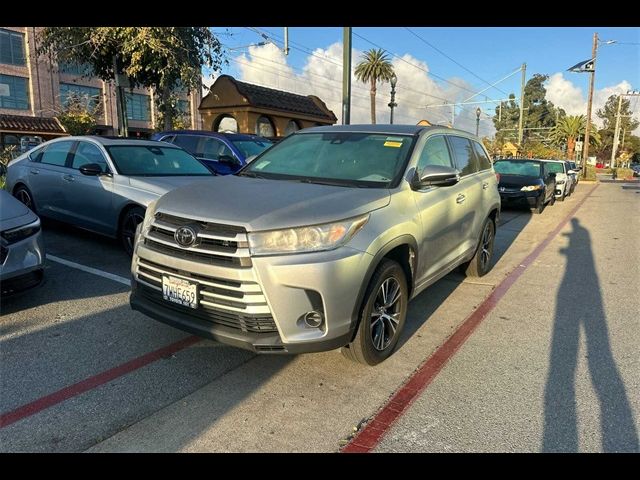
left=239, top=132, right=413, bottom=188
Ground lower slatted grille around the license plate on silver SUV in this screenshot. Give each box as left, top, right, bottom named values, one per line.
left=136, top=259, right=277, bottom=333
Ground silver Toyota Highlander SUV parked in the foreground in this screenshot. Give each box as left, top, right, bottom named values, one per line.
left=131, top=125, right=500, bottom=365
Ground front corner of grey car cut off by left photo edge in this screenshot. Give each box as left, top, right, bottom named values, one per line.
left=0, top=190, right=45, bottom=296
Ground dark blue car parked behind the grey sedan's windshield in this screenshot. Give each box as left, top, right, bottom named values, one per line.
left=151, top=130, right=273, bottom=175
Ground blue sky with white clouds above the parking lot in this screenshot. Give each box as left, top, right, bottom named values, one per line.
left=204, top=26, right=640, bottom=137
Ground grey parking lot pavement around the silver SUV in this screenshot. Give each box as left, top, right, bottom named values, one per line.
left=0, top=183, right=640, bottom=452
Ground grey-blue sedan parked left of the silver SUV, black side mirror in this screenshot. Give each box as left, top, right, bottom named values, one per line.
left=6, top=136, right=213, bottom=253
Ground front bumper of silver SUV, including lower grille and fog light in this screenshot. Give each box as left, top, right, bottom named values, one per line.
left=130, top=238, right=373, bottom=353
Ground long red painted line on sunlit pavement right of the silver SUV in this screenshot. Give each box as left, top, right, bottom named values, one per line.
left=341, top=184, right=598, bottom=453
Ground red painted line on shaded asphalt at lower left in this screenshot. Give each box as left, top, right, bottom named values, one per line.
left=0, top=336, right=202, bottom=428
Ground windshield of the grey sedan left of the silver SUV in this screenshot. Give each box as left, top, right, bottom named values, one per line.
left=107, top=145, right=212, bottom=176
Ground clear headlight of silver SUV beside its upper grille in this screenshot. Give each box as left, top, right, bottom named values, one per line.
left=249, top=214, right=369, bottom=255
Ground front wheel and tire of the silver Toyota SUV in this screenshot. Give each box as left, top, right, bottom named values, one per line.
left=342, top=258, right=409, bottom=366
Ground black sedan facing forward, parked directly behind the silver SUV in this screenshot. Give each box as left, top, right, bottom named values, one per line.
left=493, top=159, right=556, bottom=213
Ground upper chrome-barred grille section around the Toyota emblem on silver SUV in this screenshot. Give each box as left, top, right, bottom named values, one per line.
left=144, top=212, right=252, bottom=268
